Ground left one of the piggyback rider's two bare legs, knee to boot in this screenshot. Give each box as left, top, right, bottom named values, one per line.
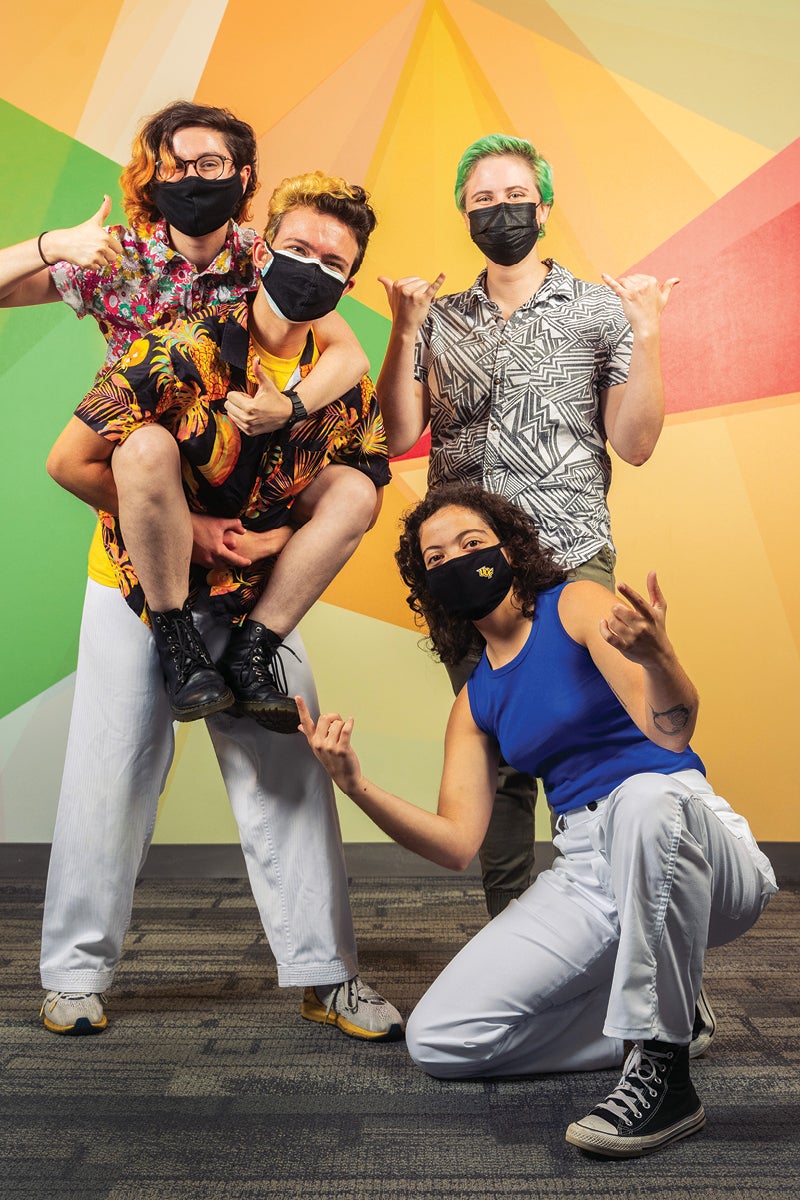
left=112, top=425, right=192, bottom=612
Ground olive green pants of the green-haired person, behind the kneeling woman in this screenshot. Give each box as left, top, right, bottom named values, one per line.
left=447, top=546, right=615, bottom=917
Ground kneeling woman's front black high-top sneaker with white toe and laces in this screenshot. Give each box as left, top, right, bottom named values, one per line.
left=566, top=1042, right=705, bottom=1158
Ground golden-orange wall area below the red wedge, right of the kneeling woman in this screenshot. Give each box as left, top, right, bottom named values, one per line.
left=612, top=406, right=800, bottom=840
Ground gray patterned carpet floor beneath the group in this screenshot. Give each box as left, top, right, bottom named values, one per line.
left=0, top=877, right=800, bottom=1200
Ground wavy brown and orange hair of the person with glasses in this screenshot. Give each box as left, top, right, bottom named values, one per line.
left=120, top=100, right=258, bottom=227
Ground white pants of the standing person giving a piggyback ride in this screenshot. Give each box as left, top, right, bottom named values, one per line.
left=41, top=580, right=357, bottom=991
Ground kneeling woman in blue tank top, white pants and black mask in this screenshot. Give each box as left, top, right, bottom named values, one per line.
left=299, top=485, right=777, bottom=1158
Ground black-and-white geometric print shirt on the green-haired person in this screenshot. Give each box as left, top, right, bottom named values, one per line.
left=415, top=259, right=633, bottom=568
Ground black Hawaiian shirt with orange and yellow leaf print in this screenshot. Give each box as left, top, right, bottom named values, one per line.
left=76, top=301, right=391, bottom=622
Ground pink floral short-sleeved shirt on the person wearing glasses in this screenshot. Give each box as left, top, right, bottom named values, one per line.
left=50, top=220, right=258, bottom=377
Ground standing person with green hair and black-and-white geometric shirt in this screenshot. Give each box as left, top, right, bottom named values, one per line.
left=377, top=133, right=678, bottom=917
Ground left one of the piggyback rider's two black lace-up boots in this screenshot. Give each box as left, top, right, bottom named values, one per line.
left=150, top=600, right=234, bottom=721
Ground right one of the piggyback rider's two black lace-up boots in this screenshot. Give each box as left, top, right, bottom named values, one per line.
left=219, top=620, right=300, bottom=733
